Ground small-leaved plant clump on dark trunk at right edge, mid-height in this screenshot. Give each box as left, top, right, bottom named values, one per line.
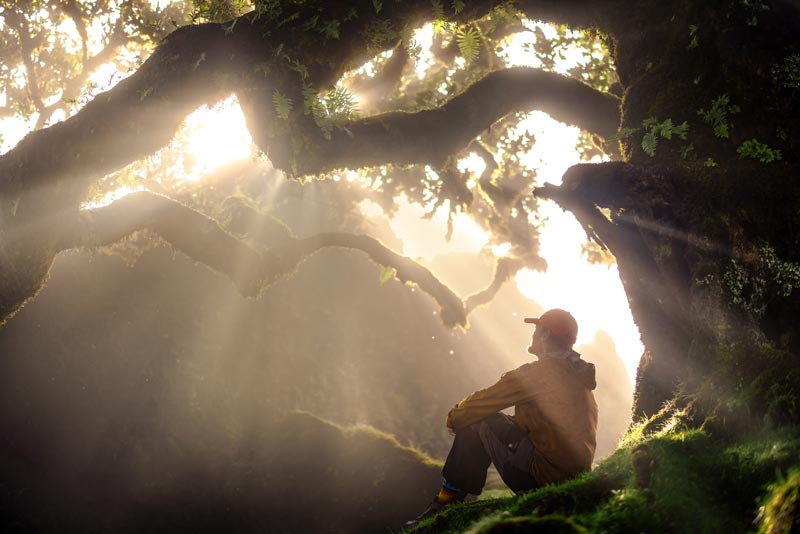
left=723, top=244, right=800, bottom=317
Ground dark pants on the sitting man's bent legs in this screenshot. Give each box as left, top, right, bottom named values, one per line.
left=442, top=413, right=538, bottom=495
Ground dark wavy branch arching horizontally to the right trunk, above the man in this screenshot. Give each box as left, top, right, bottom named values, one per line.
left=278, top=67, right=620, bottom=174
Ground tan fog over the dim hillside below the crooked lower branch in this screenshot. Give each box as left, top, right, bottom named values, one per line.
left=0, top=183, right=631, bottom=532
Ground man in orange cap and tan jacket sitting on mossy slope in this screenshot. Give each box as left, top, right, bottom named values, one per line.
left=406, top=309, right=597, bottom=527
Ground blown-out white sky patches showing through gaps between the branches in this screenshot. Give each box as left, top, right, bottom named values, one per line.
left=0, top=18, right=643, bottom=383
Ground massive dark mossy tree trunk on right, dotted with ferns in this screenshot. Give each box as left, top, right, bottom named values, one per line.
left=552, top=0, right=800, bottom=420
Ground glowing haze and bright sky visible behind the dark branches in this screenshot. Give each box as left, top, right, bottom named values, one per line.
left=0, top=8, right=642, bottom=534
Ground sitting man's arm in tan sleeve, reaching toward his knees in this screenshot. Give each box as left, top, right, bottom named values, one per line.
left=445, top=368, right=531, bottom=431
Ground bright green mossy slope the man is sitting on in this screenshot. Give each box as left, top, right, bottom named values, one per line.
left=406, top=409, right=800, bottom=533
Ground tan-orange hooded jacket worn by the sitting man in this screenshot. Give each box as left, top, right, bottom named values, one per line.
left=446, top=350, right=597, bottom=484
